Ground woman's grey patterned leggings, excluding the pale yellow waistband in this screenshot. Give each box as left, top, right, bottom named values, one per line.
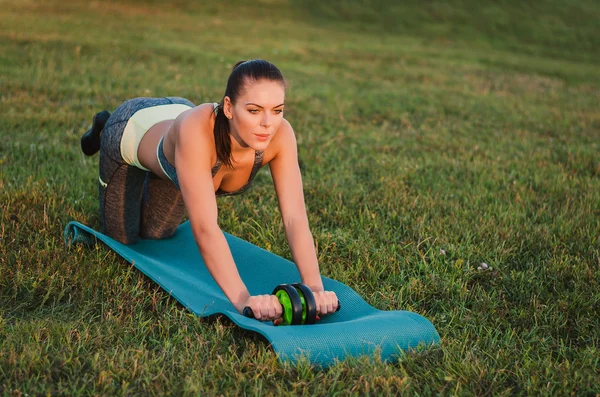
left=99, top=97, right=195, bottom=244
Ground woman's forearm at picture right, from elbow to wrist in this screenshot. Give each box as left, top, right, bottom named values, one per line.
left=285, top=218, right=323, bottom=291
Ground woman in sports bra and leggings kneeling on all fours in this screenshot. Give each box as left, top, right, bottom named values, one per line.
left=81, top=59, right=338, bottom=321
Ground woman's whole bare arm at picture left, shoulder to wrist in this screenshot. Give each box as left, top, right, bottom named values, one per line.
left=174, top=112, right=250, bottom=312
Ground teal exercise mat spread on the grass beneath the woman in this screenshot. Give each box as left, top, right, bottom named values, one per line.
left=64, top=222, right=440, bottom=367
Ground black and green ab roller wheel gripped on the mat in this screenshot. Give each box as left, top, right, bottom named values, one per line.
left=244, top=283, right=340, bottom=325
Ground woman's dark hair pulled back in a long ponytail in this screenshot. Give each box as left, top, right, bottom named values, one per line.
left=213, top=59, right=285, bottom=167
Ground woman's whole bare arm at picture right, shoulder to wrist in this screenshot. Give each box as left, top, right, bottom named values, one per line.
left=269, top=120, right=323, bottom=292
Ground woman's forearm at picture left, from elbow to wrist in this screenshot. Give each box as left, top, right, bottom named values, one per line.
left=194, top=228, right=250, bottom=312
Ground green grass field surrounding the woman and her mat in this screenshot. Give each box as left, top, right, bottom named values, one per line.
left=0, top=0, right=600, bottom=396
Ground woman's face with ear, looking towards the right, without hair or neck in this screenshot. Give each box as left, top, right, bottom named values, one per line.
left=224, top=80, right=285, bottom=150
